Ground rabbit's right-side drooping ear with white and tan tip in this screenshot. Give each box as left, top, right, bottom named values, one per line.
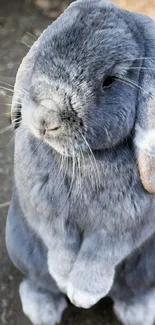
left=134, top=14, right=155, bottom=193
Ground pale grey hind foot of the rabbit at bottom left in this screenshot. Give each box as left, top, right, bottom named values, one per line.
left=19, top=279, right=67, bottom=325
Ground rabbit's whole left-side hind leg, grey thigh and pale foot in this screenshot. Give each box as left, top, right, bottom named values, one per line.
left=6, top=193, right=67, bottom=325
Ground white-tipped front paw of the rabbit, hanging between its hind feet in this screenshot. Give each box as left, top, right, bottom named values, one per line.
left=67, top=272, right=114, bottom=309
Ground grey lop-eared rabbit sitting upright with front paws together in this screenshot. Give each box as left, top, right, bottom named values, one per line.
left=6, top=0, right=155, bottom=325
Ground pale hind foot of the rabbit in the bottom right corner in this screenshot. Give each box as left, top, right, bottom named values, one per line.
left=114, top=290, right=155, bottom=325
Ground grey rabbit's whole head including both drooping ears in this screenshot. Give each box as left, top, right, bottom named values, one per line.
left=12, top=0, right=155, bottom=190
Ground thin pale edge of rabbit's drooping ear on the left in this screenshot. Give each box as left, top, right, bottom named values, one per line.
left=11, top=40, right=39, bottom=129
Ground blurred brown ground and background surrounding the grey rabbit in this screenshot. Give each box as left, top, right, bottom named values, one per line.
left=0, top=0, right=155, bottom=325
